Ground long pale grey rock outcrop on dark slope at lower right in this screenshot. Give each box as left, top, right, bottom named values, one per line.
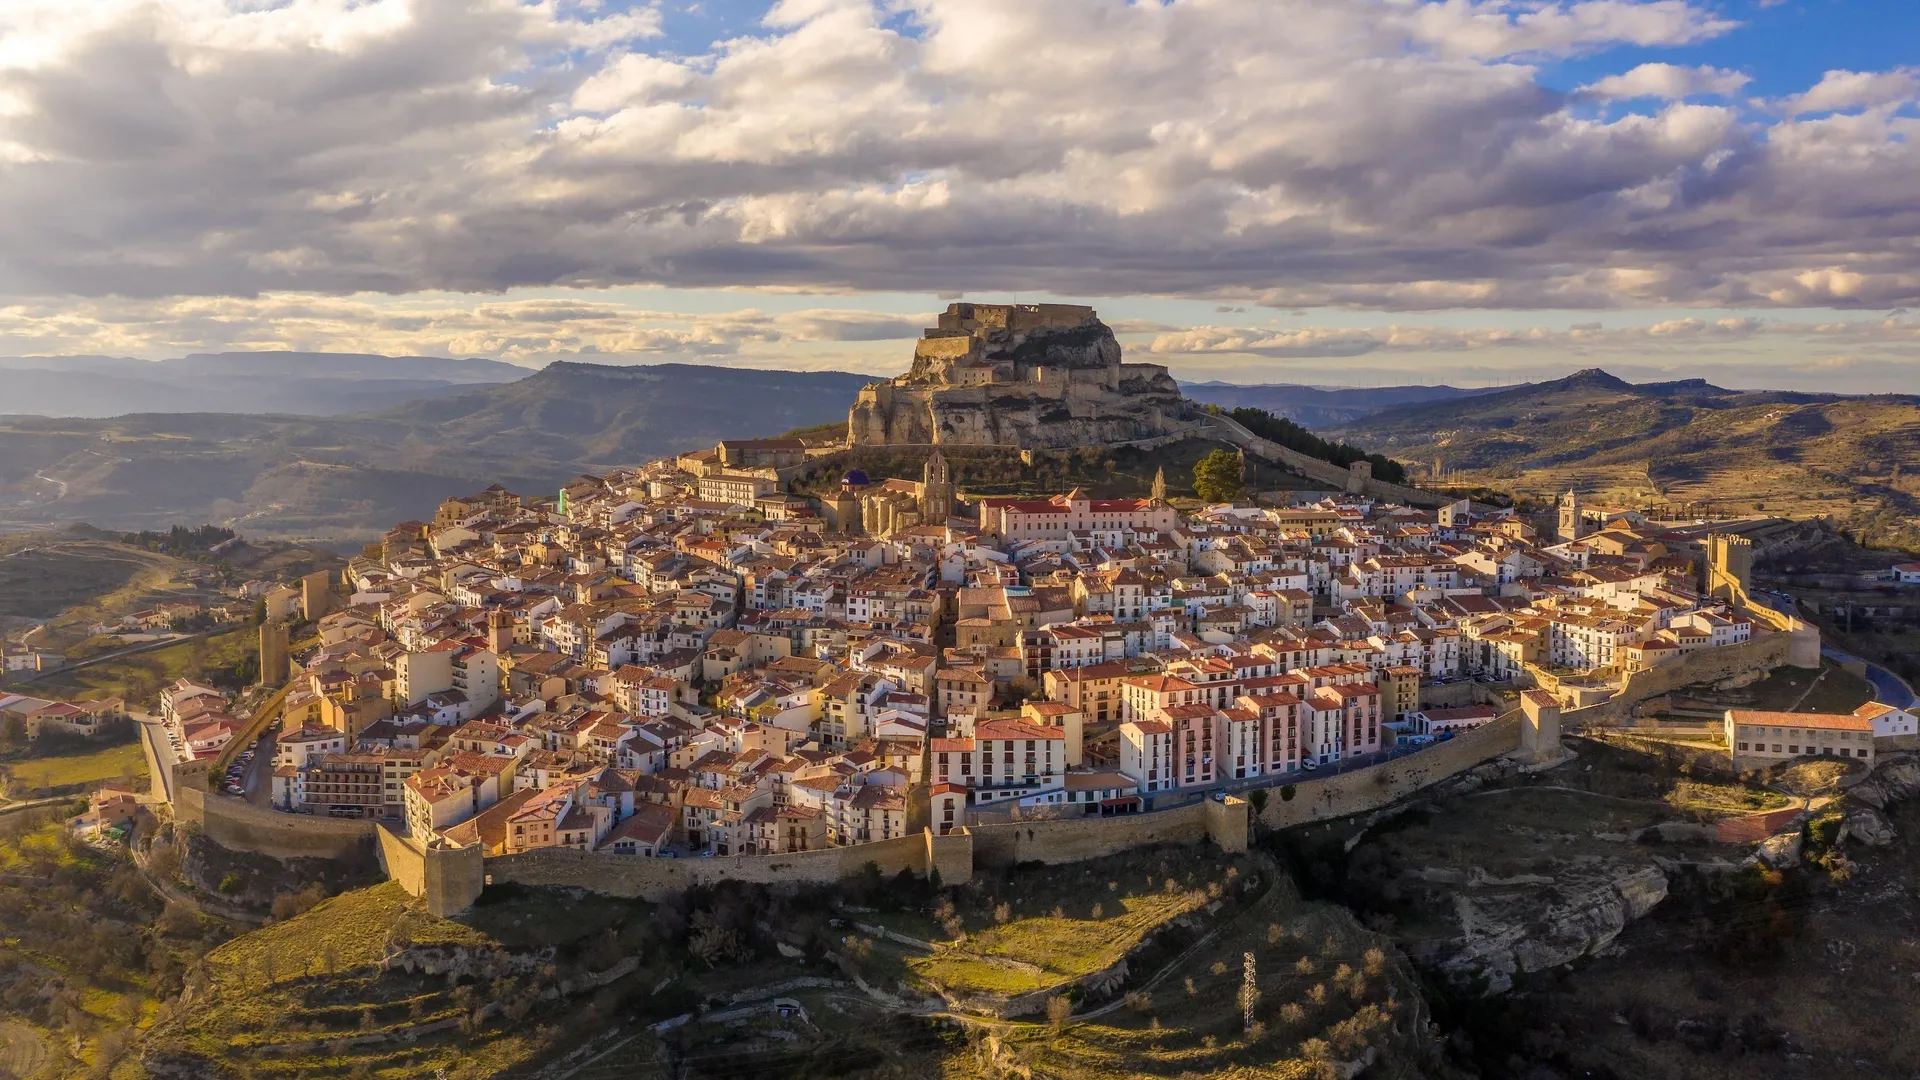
left=1434, top=867, right=1667, bottom=994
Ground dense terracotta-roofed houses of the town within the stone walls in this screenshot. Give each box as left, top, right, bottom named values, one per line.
left=123, top=306, right=1889, bottom=891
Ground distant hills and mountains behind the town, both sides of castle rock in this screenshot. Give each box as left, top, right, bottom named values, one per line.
left=0, top=354, right=1920, bottom=542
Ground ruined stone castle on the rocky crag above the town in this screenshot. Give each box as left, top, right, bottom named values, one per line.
left=847, top=304, right=1200, bottom=450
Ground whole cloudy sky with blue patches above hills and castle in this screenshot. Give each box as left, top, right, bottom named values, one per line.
left=0, top=0, right=1920, bottom=386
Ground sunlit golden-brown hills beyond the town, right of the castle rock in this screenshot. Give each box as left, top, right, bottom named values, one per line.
left=1329, top=369, right=1920, bottom=548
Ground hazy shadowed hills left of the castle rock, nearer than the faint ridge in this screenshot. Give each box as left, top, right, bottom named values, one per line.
left=0, top=363, right=870, bottom=540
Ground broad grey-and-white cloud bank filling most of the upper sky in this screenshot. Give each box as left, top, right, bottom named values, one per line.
left=0, top=0, right=1920, bottom=311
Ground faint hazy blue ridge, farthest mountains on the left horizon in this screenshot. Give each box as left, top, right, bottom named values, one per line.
left=0, top=352, right=532, bottom=417
